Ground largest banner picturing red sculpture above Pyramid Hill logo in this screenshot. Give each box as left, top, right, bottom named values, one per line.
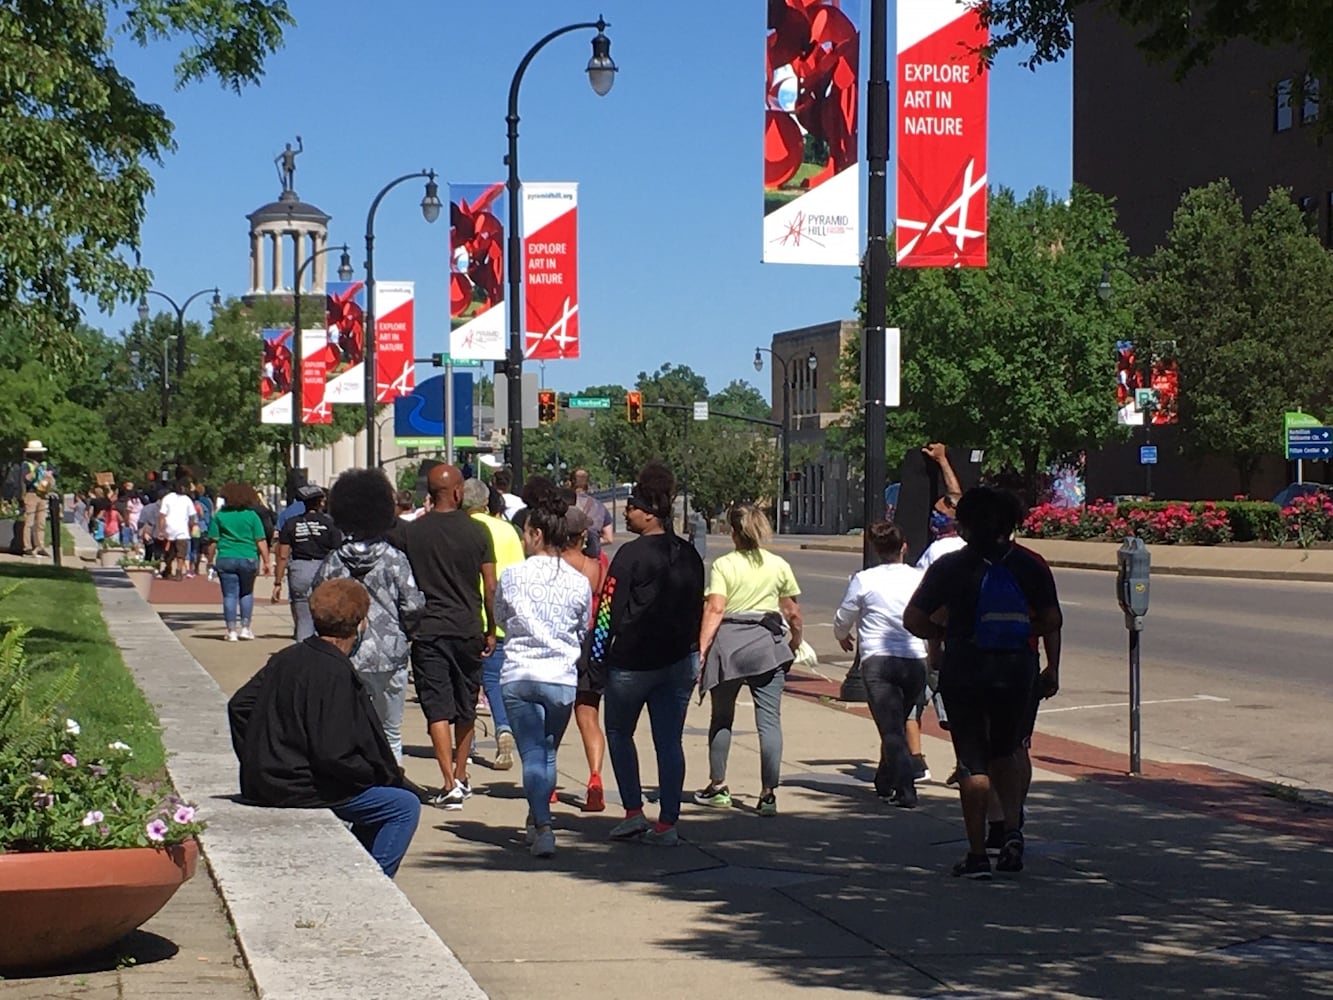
left=764, top=0, right=863, bottom=264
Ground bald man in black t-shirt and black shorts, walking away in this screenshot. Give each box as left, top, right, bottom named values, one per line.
left=399, top=465, right=496, bottom=809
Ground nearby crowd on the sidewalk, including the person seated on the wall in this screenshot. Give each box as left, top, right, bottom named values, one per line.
left=223, top=445, right=1061, bottom=879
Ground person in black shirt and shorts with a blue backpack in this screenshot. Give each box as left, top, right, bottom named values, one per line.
left=902, top=488, right=1062, bottom=879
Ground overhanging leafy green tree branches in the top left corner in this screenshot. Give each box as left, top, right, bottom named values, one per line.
left=0, top=0, right=295, bottom=364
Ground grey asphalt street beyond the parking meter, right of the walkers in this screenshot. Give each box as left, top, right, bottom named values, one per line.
left=767, top=539, right=1333, bottom=792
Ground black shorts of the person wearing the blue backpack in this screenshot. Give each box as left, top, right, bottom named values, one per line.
left=940, top=653, right=1037, bottom=775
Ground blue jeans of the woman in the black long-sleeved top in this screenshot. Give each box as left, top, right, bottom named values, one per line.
left=603, top=653, right=698, bottom=824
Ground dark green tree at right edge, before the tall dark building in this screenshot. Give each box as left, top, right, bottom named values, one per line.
left=1144, top=180, right=1333, bottom=492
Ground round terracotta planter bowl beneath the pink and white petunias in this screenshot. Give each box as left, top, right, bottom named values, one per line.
left=0, top=840, right=199, bottom=971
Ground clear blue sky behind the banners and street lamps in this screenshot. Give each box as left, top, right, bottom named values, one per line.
left=101, top=0, right=1072, bottom=400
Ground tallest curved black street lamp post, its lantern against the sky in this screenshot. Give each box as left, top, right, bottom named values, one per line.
left=496, top=17, right=616, bottom=489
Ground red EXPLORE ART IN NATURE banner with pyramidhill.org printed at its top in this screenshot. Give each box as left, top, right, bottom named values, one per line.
left=523, top=184, right=579, bottom=361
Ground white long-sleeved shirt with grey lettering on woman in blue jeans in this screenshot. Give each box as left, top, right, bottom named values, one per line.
left=496, top=557, right=592, bottom=687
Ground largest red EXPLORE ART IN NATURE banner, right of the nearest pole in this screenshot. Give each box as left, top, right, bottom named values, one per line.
left=894, top=0, right=990, bottom=267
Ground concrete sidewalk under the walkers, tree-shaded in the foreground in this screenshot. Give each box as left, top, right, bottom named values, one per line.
left=163, top=600, right=1333, bottom=1000
